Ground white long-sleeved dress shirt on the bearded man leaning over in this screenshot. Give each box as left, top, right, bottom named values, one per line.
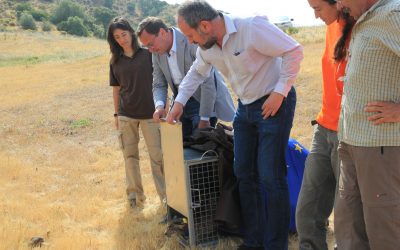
left=175, top=15, right=303, bottom=104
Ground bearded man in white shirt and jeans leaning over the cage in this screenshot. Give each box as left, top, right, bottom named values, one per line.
left=167, top=1, right=303, bottom=249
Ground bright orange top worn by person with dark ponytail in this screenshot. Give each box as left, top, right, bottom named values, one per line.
left=316, top=21, right=349, bottom=131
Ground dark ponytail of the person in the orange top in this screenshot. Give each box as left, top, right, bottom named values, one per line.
left=325, top=0, right=355, bottom=61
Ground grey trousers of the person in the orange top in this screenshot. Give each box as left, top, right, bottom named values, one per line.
left=296, top=124, right=339, bottom=250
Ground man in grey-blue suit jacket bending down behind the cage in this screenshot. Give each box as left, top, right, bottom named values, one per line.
left=137, top=17, right=235, bottom=136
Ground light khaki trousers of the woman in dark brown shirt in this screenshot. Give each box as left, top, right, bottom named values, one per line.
left=118, top=116, right=166, bottom=201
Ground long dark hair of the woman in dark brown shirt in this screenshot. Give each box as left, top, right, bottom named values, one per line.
left=107, top=17, right=140, bottom=64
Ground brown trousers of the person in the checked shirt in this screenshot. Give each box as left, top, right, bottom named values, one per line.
left=335, top=142, right=400, bottom=250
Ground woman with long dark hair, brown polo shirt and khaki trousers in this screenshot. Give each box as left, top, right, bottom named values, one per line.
left=107, top=17, right=165, bottom=207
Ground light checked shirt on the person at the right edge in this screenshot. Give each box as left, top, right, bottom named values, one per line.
left=338, top=0, right=400, bottom=147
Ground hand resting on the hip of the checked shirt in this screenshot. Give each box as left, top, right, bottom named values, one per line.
left=364, top=102, right=400, bottom=125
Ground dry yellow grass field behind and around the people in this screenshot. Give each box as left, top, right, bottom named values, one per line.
left=0, top=27, right=332, bottom=250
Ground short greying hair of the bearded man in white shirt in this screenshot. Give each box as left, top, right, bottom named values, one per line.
left=178, top=0, right=219, bottom=29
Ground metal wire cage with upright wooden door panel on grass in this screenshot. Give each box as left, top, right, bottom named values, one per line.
left=161, top=120, right=220, bottom=247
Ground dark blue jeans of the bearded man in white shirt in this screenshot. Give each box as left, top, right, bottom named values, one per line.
left=233, top=88, right=296, bottom=249
